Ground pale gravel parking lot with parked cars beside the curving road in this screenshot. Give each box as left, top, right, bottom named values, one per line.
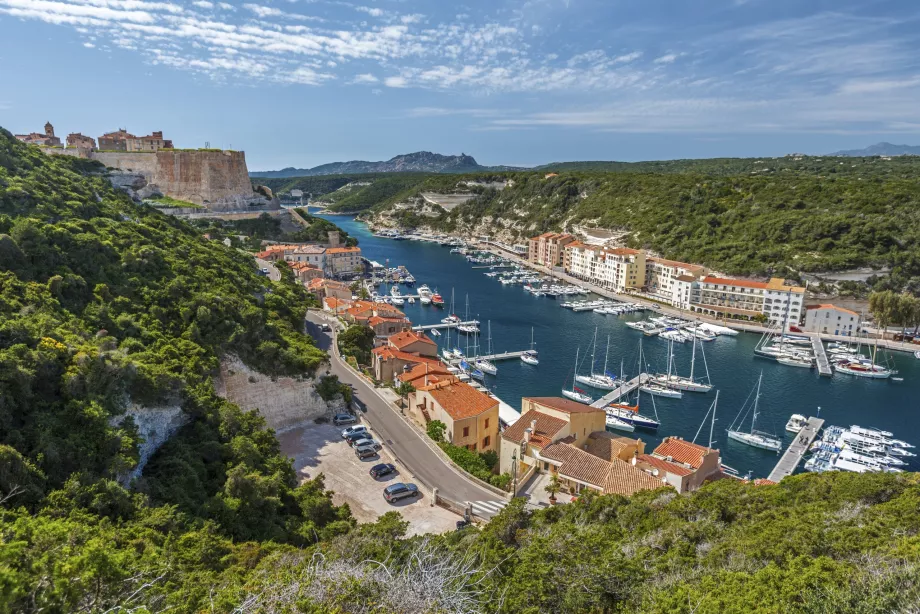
left=278, top=424, right=460, bottom=535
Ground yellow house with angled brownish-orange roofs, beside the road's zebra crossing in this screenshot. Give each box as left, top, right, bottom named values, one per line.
left=499, top=397, right=607, bottom=477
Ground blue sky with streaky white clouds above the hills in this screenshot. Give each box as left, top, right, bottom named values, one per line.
left=0, top=0, right=920, bottom=170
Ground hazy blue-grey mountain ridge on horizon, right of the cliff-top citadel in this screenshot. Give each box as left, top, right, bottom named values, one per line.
left=249, top=151, right=513, bottom=177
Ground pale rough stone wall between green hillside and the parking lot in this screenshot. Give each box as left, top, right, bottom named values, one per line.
left=215, top=358, right=345, bottom=431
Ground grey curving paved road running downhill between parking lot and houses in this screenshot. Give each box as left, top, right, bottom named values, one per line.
left=307, top=312, right=504, bottom=517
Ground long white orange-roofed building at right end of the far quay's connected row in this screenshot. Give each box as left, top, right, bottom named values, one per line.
left=690, top=276, right=805, bottom=328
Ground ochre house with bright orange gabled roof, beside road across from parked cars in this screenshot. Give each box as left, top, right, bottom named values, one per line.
left=409, top=378, right=499, bottom=452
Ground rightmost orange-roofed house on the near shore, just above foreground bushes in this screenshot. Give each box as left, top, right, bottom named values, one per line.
left=633, top=437, right=725, bottom=493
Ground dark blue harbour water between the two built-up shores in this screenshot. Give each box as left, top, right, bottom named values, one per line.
left=324, top=216, right=920, bottom=477
